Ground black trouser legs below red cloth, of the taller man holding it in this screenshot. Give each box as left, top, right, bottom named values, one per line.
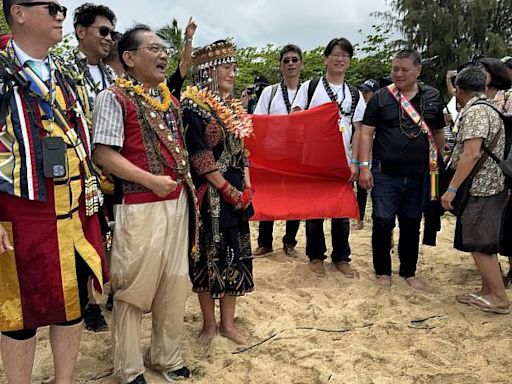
left=306, top=219, right=350, bottom=262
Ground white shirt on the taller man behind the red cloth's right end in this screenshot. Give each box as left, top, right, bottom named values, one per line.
left=292, top=79, right=366, bottom=162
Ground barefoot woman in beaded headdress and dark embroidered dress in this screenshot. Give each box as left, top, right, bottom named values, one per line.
left=182, top=40, right=254, bottom=344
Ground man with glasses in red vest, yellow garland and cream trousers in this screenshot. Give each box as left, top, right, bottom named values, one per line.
left=93, top=25, right=199, bottom=384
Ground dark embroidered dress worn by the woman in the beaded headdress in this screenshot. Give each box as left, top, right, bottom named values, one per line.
left=182, top=87, right=254, bottom=298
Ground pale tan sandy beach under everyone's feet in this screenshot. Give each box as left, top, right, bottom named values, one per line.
left=0, top=215, right=512, bottom=384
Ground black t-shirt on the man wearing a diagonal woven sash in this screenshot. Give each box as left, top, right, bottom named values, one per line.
left=363, top=84, right=445, bottom=175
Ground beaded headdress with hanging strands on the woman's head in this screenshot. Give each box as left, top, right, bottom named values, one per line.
left=192, top=40, right=237, bottom=92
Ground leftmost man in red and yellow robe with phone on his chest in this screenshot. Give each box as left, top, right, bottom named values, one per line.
left=0, top=0, right=106, bottom=384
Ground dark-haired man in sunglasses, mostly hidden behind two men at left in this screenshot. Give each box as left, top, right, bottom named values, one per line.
left=65, top=3, right=116, bottom=332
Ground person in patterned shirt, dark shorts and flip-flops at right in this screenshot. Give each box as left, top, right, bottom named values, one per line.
left=441, top=67, right=510, bottom=314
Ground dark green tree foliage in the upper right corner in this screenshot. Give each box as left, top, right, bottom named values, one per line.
left=378, top=0, right=512, bottom=97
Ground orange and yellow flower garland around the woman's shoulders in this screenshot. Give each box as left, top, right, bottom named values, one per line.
left=184, top=87, right=253, bottom=139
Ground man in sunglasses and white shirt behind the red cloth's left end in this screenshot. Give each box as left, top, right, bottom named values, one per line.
left=253, top=44, right=304, bottom=257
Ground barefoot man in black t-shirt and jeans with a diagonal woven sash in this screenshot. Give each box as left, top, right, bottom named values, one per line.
left=359, top=49, right=444, bottom=289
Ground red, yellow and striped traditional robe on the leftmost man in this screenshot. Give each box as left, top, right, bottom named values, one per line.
left=0, top=41, right=107, bottom=331
